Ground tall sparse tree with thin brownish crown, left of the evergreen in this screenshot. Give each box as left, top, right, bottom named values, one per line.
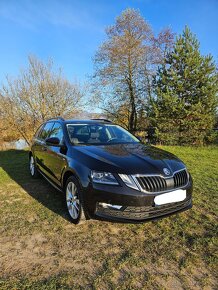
left=93, top=9, right=173, bottom=131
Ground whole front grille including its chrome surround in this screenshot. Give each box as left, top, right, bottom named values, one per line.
left=131, top=168, right=189, bottom=194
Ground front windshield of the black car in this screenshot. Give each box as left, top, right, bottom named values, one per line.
left=67, top=124, right=139, bottom=145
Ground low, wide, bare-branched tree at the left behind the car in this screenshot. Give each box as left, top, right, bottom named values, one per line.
left=0, top=56, right=84, bottom=143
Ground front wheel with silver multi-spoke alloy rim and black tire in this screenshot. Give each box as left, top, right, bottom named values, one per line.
left=64, top=176, right=86, bottom=224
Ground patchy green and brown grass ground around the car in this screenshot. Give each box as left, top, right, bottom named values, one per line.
left=0, top=147, right=218, bottom=290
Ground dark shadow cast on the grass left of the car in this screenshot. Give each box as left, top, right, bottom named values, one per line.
left=0, top=149, right=69, bottom=221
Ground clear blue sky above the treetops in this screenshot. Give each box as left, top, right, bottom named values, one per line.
left=0, top=0, right=218, bottom=83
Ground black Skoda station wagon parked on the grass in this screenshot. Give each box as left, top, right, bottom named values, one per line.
left=29, top=118, right=192, bottom=224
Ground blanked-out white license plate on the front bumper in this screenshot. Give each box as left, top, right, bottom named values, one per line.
left=154, top=189, right=186, bottom=205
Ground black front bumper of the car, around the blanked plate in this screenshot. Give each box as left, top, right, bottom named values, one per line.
left=86, top=180, right=192, bottom=222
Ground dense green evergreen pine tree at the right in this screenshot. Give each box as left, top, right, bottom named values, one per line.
left=152, top=27, right=218, bottom=145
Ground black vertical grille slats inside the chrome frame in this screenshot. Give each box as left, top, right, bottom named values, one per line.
left=135, top=169, right=188, bottom=192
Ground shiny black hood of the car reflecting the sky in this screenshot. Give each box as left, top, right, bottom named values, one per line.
left=73, top=143, right=185, bottom=176
